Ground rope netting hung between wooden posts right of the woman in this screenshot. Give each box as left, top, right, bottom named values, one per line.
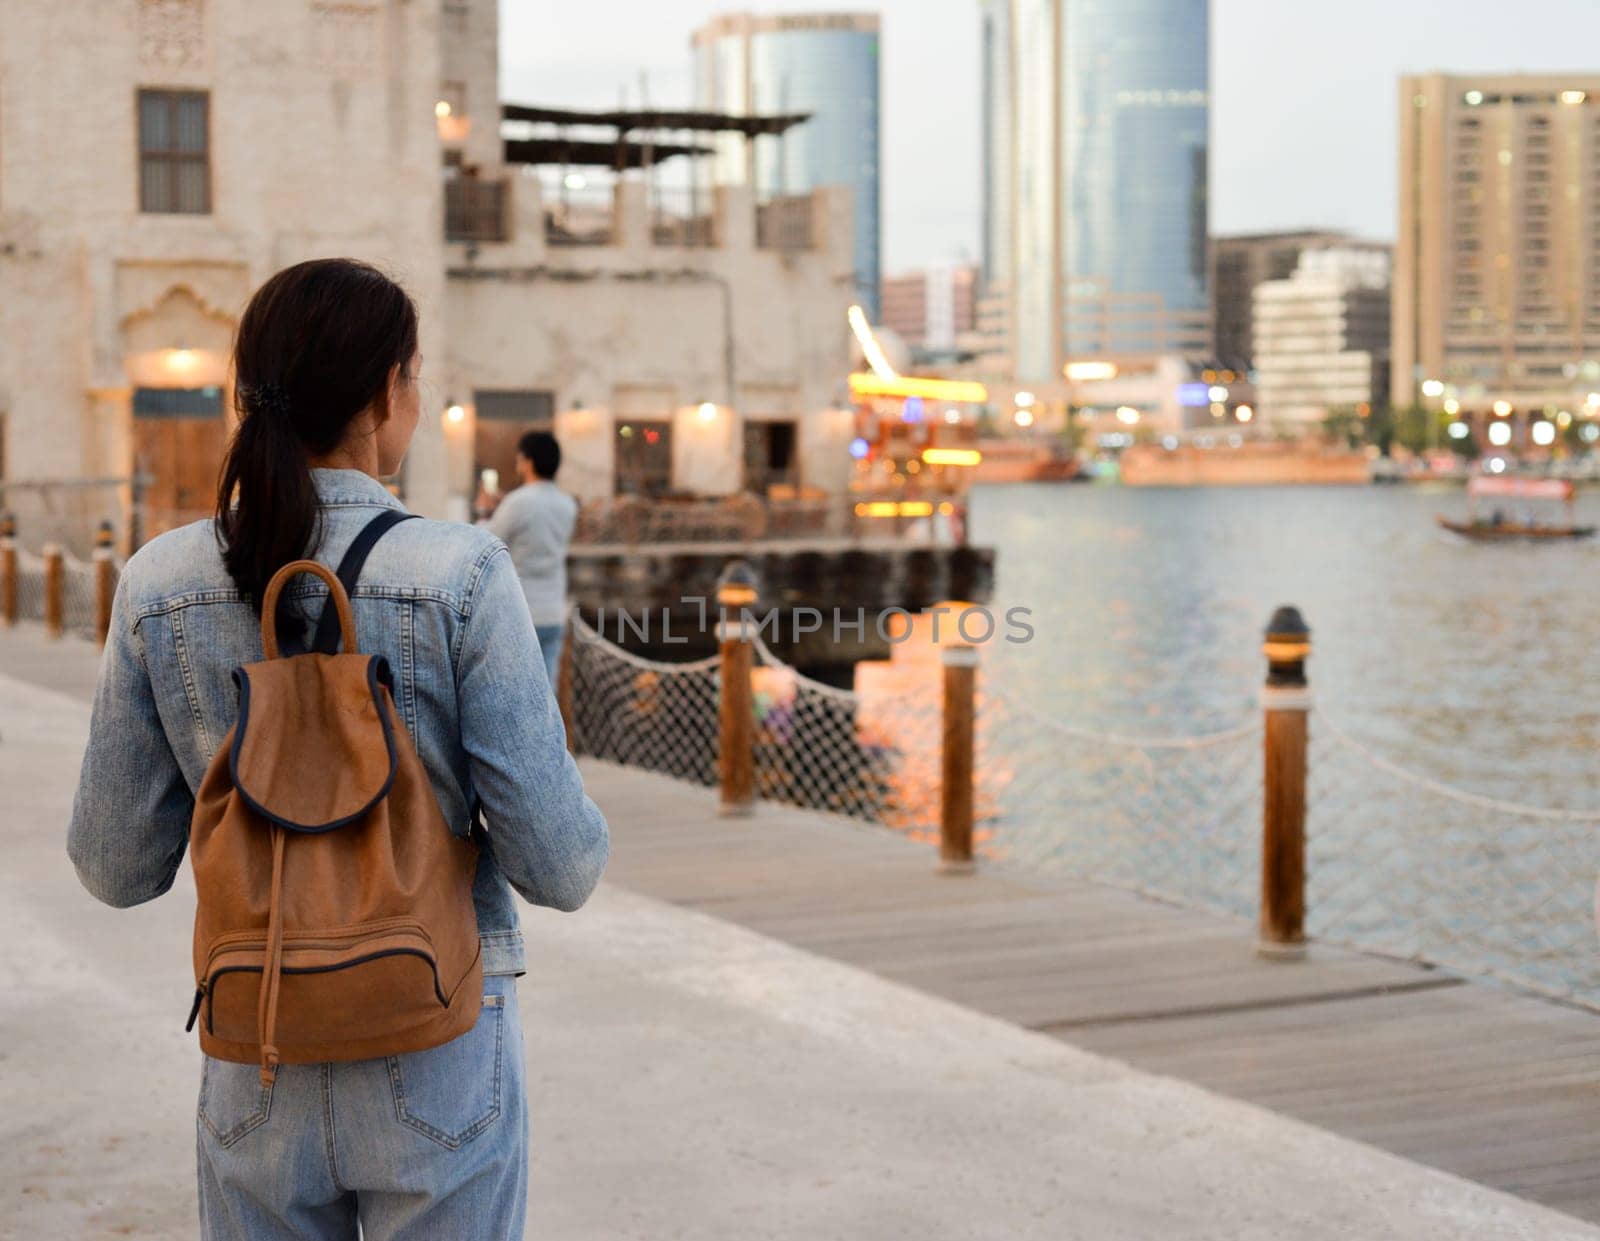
left=560, top=619, right=1600, bottom=1008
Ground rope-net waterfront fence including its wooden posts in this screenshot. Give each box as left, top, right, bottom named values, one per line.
left=12, top=534, right=1600, bottom=1009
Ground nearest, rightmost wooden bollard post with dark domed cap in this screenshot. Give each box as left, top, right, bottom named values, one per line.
left=1256, top=608, right=1310, bottom=961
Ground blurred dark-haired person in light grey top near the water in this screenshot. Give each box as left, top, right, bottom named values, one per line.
left=488, top=430, right=578, bottom=686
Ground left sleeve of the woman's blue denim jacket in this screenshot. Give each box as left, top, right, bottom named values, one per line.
left=67, top=577, right=194, bottom=907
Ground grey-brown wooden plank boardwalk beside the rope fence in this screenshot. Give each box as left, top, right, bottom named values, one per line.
left=586, top=761, right=1600, bottom=1220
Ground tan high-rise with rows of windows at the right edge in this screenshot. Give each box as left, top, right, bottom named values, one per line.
left=1390, top=74, right=1600, bottom=414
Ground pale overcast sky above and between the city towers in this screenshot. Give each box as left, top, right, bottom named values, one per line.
left=501, top=0, right=1600, bottom=273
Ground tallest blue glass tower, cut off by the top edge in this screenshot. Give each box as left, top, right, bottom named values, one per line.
left=984, top=0, right=1210, bottom=382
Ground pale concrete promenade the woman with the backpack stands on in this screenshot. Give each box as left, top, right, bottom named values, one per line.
left=0, top=628, right=1600, bottom=1241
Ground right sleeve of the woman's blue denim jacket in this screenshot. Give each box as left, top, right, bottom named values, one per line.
left=456, top=542, right=611, bottom=910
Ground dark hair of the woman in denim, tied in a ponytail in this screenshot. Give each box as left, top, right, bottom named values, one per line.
left=216, top=259, right=416, bottom=611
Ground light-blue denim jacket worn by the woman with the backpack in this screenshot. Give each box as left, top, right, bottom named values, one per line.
left=67, top=470, right=610, bottom=974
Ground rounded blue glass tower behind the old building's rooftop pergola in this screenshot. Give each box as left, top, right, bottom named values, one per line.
left=693, top=13, right=880, bottom=318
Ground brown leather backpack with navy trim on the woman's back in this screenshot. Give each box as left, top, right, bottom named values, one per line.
left=189, top=513, right=483, bottom=1086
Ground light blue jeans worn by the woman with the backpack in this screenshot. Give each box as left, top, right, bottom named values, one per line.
left=197, top=974, right=528, bottom=1241
